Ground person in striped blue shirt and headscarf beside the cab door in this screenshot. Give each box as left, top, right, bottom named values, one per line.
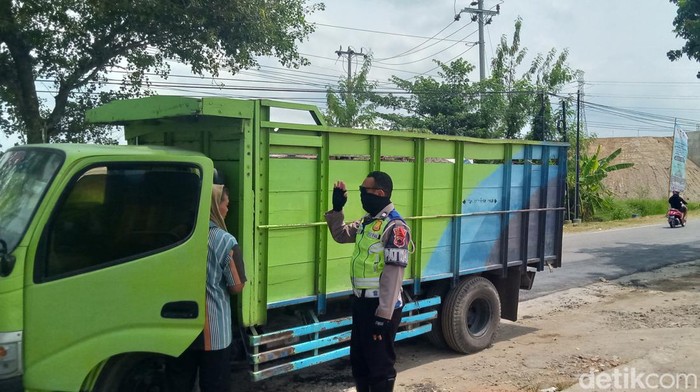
left=168, top=184, right=246, bottom=392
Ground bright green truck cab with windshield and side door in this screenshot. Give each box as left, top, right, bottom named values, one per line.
left=0, top=144, right=213, bottom=391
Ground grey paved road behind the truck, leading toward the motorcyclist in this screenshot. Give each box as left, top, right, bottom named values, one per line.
left=520, top=217, right=700, bottom=300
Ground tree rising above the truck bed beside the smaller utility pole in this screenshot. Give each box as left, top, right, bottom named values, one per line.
left=326, top=58, right=377, bottom=128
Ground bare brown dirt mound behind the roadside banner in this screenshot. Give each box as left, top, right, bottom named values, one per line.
left=588, top=137, right=700, bottom=201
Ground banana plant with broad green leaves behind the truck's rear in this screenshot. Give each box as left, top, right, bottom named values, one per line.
left=567, top=146, right=634, bottom=220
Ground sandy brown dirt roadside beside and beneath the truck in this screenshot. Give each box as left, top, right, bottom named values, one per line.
left=237, top=260, right=700, bottom=392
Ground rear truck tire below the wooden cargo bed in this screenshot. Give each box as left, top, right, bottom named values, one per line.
left=442, top=276, right=501, bottom=354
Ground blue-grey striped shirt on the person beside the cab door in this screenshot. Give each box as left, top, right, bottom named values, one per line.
left=204, top=222, right=244, bottom=351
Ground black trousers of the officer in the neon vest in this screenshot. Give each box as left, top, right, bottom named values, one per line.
left=350, top=296, right=401, bottom=385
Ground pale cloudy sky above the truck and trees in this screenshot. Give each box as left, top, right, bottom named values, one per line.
left=0, top=0, right=700, bottom=147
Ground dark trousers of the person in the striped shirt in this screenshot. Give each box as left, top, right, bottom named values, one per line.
left=166, top=339, right=231, bottom=392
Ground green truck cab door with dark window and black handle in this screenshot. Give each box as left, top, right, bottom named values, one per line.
left=24, top=157, right=212, bottom=390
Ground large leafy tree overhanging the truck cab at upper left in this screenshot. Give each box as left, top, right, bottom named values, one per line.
left=0, top=0, right=323, bottom=143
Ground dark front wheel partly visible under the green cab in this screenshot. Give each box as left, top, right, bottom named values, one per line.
left=93, top=353, right=168, bottom=392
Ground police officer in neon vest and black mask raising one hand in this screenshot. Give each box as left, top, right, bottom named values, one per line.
left=325, top=171, right=411, bottom=392
